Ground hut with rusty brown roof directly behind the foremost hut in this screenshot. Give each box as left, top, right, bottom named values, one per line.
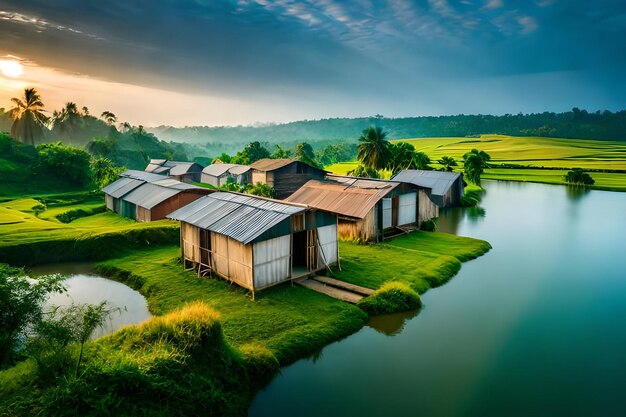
left=286, top=175, right=434, bottom=241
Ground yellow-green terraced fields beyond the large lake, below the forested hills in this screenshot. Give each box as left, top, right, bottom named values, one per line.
left=326, top=135, right=626, bottom=191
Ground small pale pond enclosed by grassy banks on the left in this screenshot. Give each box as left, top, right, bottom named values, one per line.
left=30, top=263, right=151, bottom=338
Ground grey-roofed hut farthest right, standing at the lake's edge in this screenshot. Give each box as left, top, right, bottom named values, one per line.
left=392, top=169, right=464, bottom=208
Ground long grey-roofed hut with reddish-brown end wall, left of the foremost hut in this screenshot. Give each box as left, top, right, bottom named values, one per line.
left=102, top=171, right=212, bottom=222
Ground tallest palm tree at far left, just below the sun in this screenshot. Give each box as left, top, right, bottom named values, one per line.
left=9, top=88, right=48, bottom=146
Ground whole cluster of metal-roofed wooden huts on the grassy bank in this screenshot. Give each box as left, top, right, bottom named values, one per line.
left=102, top=159, right=463, bottom=292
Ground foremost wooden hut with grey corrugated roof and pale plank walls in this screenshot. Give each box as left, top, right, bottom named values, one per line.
left=167, top=192, right=339, bottom=291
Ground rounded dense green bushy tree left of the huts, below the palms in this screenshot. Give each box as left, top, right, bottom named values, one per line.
left=36, top=142, right=91, bottom=185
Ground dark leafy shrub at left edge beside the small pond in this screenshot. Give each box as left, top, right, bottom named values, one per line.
left=0, top=264, right=65, bottom=368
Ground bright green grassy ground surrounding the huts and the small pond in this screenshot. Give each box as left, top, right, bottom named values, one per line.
left=0, top=191, right=490, bottom=415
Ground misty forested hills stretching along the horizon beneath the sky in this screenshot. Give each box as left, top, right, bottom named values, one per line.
left=147, top=108, right=626, bottom=148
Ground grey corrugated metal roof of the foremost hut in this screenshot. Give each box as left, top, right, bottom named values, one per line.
left=167, top=192, right=306, bottom=243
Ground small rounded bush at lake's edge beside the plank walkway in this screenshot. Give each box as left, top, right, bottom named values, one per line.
left=357, top=281, right=422, bottom=316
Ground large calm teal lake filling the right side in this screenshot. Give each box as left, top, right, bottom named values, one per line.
left=249, top=182, right=626, bottom=417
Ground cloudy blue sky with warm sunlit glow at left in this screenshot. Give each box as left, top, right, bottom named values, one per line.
left=0, top=0, right=626, bottom=126
